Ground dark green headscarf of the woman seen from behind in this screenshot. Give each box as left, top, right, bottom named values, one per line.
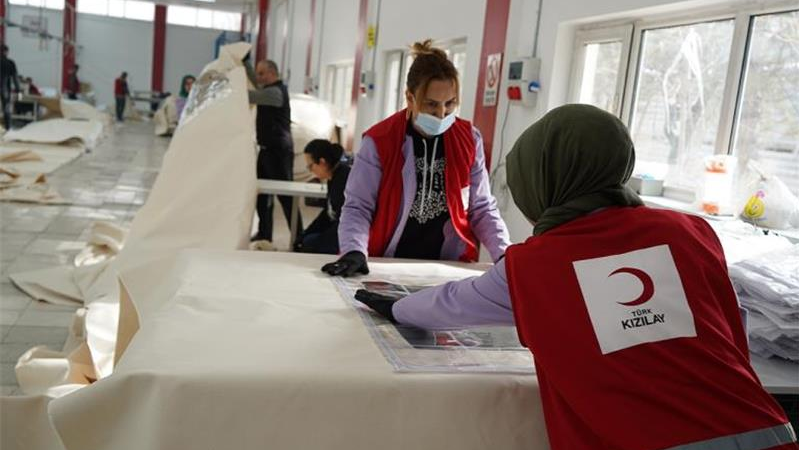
left=507, top=104, right=643, bottom=236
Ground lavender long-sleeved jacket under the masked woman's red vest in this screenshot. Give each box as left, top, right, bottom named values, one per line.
left=338, top=127, right=510, bottom=261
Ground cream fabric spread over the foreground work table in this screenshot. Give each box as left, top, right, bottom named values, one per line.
left=50, top=250, right=547, bottom=450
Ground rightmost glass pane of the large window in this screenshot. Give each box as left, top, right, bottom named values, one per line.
left=734, top=11, right=799, bottom=194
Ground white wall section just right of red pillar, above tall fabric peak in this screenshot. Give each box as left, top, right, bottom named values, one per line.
left=163, top=25, right=221, bottom=94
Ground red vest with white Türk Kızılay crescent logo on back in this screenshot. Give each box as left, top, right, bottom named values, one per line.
left=505, top=207, right=799, bottom=450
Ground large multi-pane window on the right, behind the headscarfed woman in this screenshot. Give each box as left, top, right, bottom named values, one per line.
left=570, top=5, right=799, bottom=201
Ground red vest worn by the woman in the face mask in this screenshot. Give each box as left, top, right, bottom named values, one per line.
left=364, top=109, right=477, bottom=262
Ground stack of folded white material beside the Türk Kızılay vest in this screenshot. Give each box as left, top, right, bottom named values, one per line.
left=730, top=245, right=799, bottom=361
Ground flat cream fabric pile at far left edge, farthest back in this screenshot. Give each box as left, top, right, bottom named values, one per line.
left=3, top=119, right=103, bottom=149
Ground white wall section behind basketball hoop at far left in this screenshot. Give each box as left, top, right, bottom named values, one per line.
left=6, top=5, right=63, bottom=91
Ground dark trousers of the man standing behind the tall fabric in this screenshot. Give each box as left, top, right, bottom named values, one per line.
left=256, top=147, right=302, bottom=241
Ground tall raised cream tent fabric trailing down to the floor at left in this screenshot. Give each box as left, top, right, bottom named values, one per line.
left=0, top=43, right=257, bottom=450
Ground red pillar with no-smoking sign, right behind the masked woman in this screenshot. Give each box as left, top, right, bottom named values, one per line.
left=473, top=0, right=510, bottom=167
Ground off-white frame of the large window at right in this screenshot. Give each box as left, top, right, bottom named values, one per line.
left=568, top=1, right=799, bottom=202
